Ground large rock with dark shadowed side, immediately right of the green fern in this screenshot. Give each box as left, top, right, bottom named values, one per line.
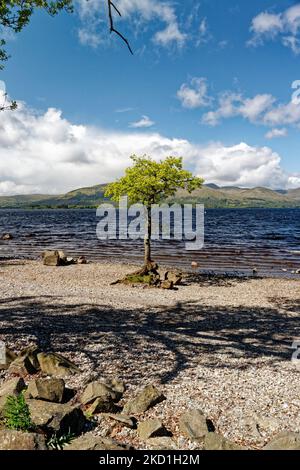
left=27, top=400, right=86, bottom=436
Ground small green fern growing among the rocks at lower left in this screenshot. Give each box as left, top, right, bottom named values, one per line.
left=3, top=393, right=34, bottom=431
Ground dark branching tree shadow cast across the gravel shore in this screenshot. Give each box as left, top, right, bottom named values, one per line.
left=0, top=296, right=300, bottom=384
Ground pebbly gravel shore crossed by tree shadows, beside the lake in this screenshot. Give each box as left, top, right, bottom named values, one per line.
left=0, top=261, right=300, bottom=449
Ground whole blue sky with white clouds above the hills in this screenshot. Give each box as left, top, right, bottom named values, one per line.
left=0, top=0, right=300, bottom=194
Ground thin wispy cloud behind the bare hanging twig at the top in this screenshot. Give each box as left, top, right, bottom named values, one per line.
left=75, top=0, right=187, bottom=48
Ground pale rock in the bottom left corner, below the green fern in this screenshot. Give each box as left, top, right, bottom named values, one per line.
left=0, top=429, right=47, bottom=450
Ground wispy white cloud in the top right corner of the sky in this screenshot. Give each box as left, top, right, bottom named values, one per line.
left=248, top=3, right=300, bottom=55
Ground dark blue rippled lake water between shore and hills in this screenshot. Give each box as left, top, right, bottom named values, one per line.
left=0, top=209, right=300, bottom=277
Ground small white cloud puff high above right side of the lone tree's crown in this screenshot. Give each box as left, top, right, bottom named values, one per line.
left=177, top=77, right=211, bottom=109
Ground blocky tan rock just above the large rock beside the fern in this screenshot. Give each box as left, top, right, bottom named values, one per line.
left=26, top=378, right=65, bottom=403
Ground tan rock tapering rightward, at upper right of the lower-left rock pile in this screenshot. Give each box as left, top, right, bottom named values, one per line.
left=37, top=353, right=80, bottom=377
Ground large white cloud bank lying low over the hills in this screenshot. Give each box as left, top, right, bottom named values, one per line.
left=0, top=103, right=300, bottom=195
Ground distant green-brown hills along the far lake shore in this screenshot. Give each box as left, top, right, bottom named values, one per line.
left=0, top=184, right=300, bottom=209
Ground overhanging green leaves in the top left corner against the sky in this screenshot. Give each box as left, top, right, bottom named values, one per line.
left=0, top=0, right=73, bottom=68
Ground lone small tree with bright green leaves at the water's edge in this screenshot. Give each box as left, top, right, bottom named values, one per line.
left=105, top=155, right=203, bottom=274
